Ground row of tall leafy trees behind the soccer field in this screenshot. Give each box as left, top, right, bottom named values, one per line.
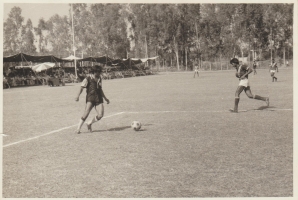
left=4, top=4, right=293, bottom=69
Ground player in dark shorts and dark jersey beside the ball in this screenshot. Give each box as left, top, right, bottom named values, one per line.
left=75, top=66, right=110, bottom=134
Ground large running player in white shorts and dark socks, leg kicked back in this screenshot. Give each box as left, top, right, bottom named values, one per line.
left=230, top=58, right=269, bottom=113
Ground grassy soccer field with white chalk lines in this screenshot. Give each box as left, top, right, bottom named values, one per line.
left=2, top=68, right=293, bottom=198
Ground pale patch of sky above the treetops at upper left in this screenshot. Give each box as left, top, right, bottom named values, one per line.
left=3, top=3, right=70, bottom=27
